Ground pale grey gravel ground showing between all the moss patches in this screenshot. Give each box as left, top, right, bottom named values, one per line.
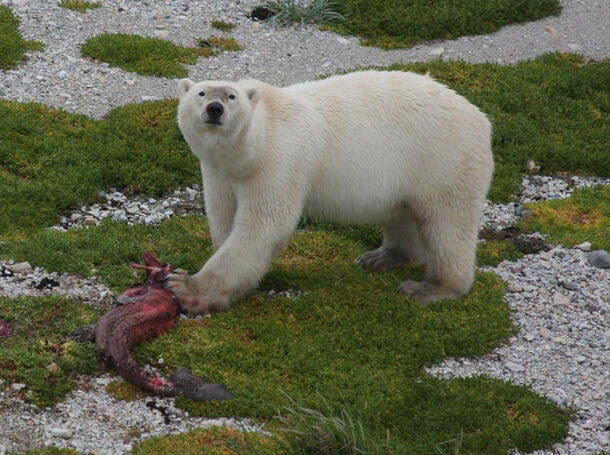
left=0, top=0, right=610, bottom=455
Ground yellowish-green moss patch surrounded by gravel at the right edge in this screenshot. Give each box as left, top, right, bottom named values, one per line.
left=518, top=186, right=610, bottom=250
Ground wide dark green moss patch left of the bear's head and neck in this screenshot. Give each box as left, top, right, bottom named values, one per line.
left=0, top=100, right=196, bottom=235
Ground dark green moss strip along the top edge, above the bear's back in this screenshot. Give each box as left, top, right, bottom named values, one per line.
left=330, top=0, right=561, bottom=49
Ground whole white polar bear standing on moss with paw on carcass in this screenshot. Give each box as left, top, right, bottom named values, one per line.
left=168, top=71, right=494, bottom=313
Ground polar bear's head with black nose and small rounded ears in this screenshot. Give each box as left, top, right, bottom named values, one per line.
left=178, top=79, right=259, bottom=136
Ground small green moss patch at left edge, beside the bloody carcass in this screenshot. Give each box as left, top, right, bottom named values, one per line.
left=0, top=297, right=100, bottom=405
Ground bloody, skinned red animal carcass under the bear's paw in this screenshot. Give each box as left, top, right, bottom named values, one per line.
left=95, top=252, right=234, bottom=401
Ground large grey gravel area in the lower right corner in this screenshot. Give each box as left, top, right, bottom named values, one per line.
left=427, top=247, right=610, bottom=455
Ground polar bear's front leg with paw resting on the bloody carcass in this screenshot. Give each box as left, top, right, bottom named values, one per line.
left=167, top=198, right=301, bottom=314
